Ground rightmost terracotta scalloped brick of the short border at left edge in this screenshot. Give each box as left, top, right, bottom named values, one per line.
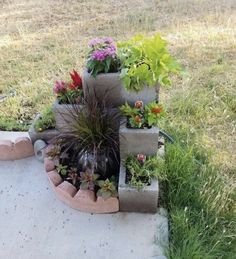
left=14, top=137, right=34, bottom=159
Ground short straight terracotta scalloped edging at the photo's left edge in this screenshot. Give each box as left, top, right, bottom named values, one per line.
left=0, top=137, right=34, bottom=160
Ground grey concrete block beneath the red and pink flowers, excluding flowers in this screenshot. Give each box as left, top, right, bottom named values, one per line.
left=52, top=100, right=82, bottom=132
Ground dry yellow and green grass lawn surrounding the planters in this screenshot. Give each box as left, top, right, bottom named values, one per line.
left=0, top=0, right=236, bottom=259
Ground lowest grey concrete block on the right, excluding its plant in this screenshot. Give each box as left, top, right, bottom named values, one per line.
left=118, top=164, right=159, bottom=213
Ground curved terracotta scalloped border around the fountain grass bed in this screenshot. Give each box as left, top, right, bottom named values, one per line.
left=44, top=146, right=119, bottom=213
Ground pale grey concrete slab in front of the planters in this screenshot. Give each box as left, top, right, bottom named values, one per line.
left=0, top=158, right=168, bottom=259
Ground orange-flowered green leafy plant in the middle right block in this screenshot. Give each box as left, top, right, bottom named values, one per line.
left=120, top=101, right=164, bottom=128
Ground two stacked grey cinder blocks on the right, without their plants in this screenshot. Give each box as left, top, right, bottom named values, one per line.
left=118, top=125, right=159, bottom=213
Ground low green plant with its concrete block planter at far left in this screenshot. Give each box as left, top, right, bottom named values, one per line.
left=28, top=107, right=59, bottom=143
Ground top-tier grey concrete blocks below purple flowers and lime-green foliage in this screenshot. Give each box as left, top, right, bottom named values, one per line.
left=83, top=70, right=159, bottom=107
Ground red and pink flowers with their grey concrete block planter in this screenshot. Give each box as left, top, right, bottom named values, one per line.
left=53, top=70, right=83, bottom=131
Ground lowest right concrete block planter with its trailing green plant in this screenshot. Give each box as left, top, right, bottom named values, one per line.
left=118, top=154, right=165, bottom=213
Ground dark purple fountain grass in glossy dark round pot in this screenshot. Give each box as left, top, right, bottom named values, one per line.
left=53, top=93, right=120, bottom=197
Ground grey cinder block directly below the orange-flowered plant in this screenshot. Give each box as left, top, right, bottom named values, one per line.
left=119, top=124, right=159, bottom=159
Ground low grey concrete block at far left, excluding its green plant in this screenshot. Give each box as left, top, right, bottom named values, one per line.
left=28, top=114, right=60, bottom=143
